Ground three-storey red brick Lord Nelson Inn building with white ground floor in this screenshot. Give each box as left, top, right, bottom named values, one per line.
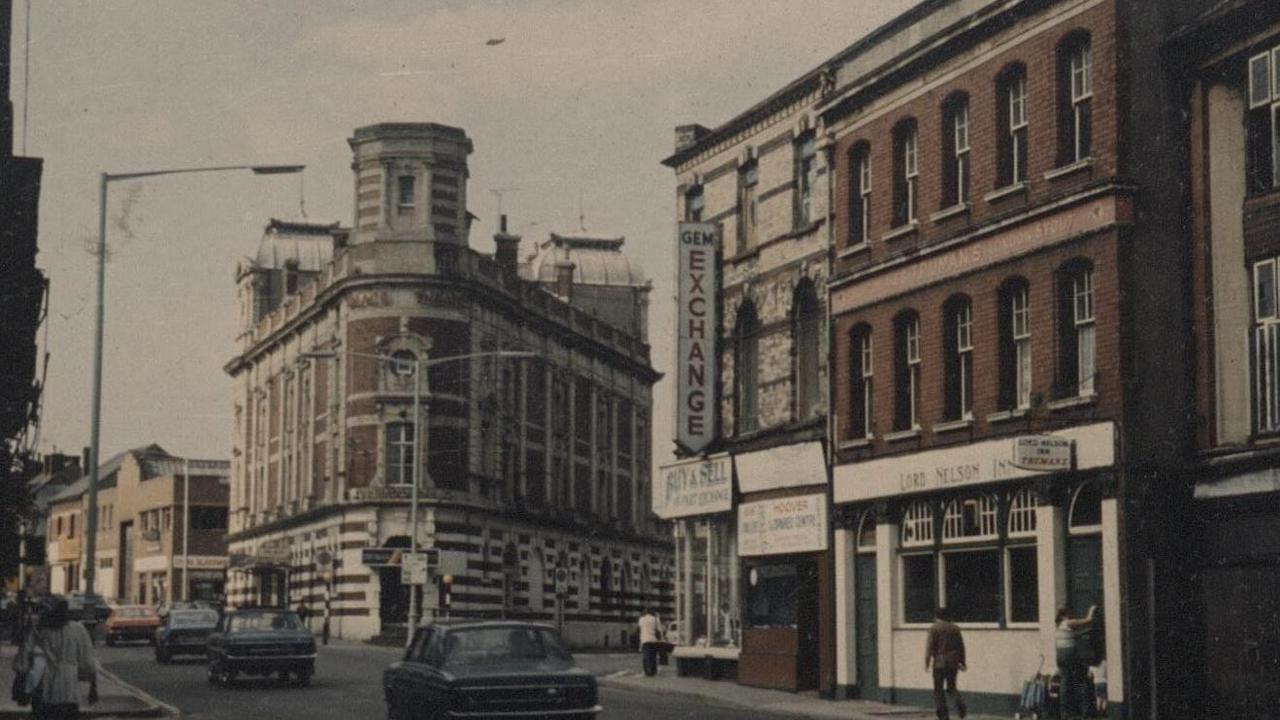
left=818, top=0, right=1196, bottom=717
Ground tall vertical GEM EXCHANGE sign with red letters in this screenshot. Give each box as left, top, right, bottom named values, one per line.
left=676, top=223, right=719, bottom=452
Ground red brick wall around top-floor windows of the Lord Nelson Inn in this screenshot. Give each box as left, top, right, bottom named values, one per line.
left=832, top=3, right=1117, bottom=277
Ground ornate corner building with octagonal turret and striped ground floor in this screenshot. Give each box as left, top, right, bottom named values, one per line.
left=227, top=123, right=672, bottom=647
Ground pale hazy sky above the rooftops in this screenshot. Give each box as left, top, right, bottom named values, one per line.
left=13, top=0, right=915, bottom=465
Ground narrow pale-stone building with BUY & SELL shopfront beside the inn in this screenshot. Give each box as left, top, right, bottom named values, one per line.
left=654, top=58, right=835, bottom=693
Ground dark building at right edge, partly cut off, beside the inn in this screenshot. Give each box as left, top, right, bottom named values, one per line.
left=1165, top=0, right=1280, bottom=719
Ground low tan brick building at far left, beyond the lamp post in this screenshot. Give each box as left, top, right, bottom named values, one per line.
left=45, top=445, right=230, bottom=605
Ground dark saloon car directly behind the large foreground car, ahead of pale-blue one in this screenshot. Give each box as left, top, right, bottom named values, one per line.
left=209, top=607, right=316, bottom=685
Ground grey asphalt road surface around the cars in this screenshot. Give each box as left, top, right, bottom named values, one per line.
left=97, top=643, right=778, bottom=720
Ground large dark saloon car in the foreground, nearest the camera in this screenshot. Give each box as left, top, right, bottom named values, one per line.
left=383, top=623, right=602, bottom=720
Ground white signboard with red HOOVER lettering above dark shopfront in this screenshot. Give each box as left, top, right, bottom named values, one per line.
left=737, top=493, right=827, bottom=557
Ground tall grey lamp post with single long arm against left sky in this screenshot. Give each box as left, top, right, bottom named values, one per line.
left=84, top=165, right=306, bottom=594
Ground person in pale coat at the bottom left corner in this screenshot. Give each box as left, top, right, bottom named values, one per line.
left=13, top=597, right=97, bottom=720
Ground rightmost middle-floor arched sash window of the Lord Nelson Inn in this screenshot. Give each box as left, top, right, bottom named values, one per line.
left=1057, top=261, right=1097, bottom=396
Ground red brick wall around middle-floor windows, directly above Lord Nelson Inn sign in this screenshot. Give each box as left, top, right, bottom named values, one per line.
left=832, top=231, right=1123, bottom=461
